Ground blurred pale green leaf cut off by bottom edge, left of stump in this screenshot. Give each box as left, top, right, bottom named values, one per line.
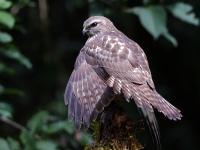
left=36, top=140, right=57, bottom=150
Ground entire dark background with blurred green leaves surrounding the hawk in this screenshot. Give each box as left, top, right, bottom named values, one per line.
left=0, top=0, right=200, bottom=150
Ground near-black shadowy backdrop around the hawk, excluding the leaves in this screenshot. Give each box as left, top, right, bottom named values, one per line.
left=0, top=0, right=200, bottom=150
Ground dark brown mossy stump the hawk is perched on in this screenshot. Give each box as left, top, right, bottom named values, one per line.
left=85, top=97, right=143, bottom=150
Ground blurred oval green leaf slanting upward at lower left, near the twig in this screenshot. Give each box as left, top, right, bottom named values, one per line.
left=27, top=111, right=49, bottom=135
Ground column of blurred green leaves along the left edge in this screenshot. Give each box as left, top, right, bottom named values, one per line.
left=0, top=0, right=33, bottom=150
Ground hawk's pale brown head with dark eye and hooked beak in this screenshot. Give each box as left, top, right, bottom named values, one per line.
left=82, top=16, right=114, bottom=37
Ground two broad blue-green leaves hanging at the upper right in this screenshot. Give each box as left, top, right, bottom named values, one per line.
left=125, top=1, right=199, bottom=46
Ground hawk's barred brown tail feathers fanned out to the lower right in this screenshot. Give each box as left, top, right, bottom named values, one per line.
left=122, top=83, right=182, bottom=149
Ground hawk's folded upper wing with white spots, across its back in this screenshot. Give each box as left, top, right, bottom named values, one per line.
left=83, top=34, right=154, bottom=88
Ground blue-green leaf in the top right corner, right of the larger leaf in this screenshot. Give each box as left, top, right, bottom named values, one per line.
left=168, top=2, right=199, bottom=26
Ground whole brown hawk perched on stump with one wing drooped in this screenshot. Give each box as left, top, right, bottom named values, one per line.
left=64, top=16, right=182, bottom=147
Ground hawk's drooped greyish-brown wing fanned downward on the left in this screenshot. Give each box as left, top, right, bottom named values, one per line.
left=65, top=52, right=114, bottom=130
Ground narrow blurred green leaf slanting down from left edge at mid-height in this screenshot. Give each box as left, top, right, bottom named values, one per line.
left=0, top=48, right=32, bottom=69
